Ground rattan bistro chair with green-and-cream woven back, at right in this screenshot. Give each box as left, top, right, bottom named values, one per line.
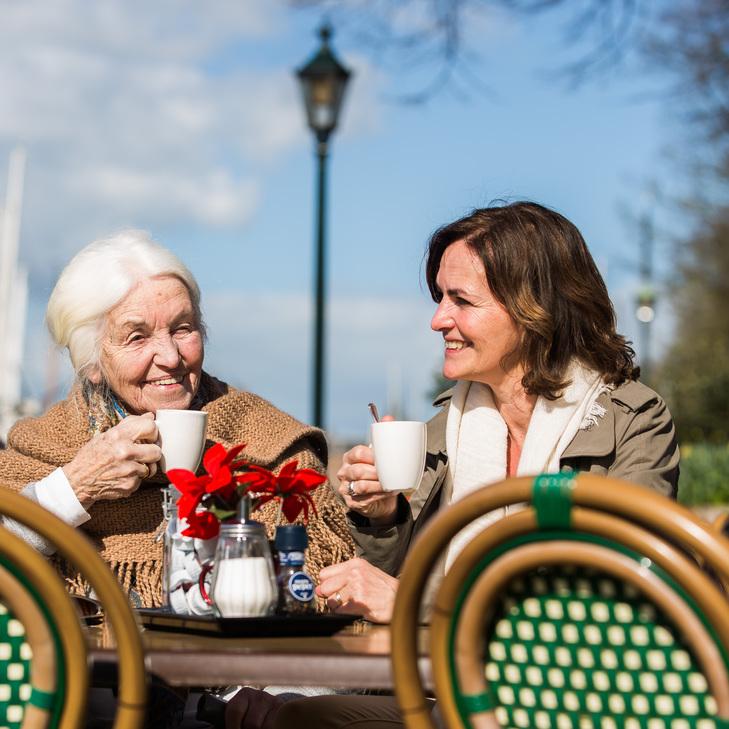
left=391, top=474, right=729, bottom=729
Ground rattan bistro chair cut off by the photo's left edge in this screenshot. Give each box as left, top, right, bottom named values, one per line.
left=0, top=488, right=147, bottom=729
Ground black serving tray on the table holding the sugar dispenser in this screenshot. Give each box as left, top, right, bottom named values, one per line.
left=137, top=608, right=361, bottom=638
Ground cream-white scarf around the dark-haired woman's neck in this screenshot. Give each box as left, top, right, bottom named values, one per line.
left=444, top=361, right=609, bottom=570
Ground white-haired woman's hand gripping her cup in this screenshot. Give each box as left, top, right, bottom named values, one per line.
left=63, top=413, right=161, bottom=509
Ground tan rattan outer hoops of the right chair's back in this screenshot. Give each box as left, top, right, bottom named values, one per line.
left=391, top=474, right=729, bottom=729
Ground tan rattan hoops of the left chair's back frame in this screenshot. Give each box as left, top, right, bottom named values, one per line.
left=0, top=488, right=147, bottom=729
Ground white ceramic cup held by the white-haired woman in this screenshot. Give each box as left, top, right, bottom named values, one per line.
left=154, top=410, right=208, bottom=472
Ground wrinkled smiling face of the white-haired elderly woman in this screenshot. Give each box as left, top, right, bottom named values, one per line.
left=92, top=276, right=204, bottom=415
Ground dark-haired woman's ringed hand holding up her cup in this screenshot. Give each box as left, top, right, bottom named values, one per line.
left=337, top=445, right=397, bottom=525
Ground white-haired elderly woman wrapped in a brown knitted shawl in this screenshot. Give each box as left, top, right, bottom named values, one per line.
left=0, top=230, right=353, bottom=606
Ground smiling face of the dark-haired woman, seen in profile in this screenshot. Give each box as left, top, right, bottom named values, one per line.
left=430, top=241, right=523, bottom=387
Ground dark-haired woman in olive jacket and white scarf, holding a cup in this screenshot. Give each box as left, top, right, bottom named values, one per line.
left=275, top=202, right=679, bottom=729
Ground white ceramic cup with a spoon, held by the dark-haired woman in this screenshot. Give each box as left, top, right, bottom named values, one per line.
left=370, top=420, right=427, bottom=491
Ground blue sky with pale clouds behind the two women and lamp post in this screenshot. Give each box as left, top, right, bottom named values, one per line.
left=0, top=0, right=675, bottom=439
